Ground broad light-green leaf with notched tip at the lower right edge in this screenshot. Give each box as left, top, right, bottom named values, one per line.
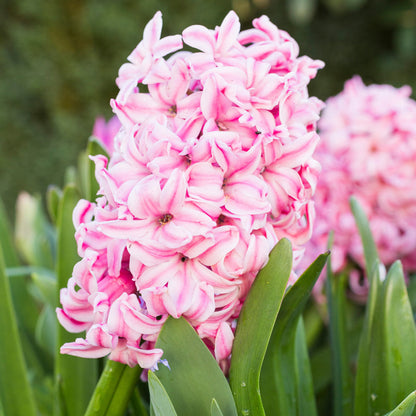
left=354, top=262, right=416, bottom=416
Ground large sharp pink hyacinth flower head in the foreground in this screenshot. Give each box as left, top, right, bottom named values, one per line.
left=58, top=12, right=323, bottom=369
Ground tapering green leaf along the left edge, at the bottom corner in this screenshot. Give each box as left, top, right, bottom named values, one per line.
left=0, top=244, right=36, bottom=416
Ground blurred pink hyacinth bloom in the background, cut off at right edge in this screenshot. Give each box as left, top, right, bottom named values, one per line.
left=305, top=76, right=416, bottom=295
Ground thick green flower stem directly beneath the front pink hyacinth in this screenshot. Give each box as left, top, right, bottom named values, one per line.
left=84, top=360, right=142, bottom=416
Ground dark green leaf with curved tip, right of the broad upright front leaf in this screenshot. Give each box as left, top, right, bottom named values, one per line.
left=261, top=253, right=328, bottom=416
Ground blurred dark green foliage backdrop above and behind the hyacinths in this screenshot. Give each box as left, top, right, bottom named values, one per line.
left=0, top=0, right=416, bottom=216
